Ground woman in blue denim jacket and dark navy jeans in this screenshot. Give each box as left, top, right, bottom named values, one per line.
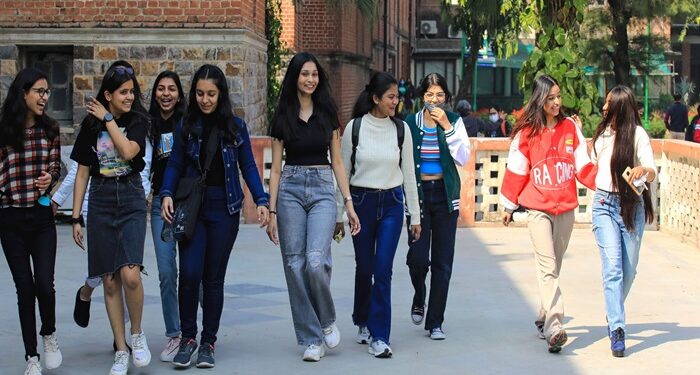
left=160, top=64, right=269, bottom=368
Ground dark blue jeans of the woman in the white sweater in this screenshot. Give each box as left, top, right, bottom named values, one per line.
left=350, top=186, right=403, bottom=344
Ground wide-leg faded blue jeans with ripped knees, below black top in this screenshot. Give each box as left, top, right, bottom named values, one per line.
left=277, top=165, right=336, bottom=346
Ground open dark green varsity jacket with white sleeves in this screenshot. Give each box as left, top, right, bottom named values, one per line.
left=406, top=111, right=471, bottom=217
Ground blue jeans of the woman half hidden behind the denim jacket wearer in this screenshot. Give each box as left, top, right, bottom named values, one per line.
left=151, top=195, right=180, bottom=337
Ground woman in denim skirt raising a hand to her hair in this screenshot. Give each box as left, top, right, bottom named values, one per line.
left=71, top=66, right=151, bottom=375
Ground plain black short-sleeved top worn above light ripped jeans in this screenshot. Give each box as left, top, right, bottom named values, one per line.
left=270, top=112, right=337, bottom=165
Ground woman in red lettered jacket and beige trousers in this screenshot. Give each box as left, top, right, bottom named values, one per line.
left=500, top=75, right=596, bottom=353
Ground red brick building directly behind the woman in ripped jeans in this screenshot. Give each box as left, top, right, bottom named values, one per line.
left=282, top=0, right=416, bottom=122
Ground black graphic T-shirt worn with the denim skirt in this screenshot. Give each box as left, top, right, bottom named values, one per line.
left=70, top=112, right=148, bottom=177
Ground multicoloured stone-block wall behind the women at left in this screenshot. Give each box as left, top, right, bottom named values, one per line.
left=0, top=29, right=267, bottom=142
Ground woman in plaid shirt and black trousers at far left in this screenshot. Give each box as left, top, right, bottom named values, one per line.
left=0, top=68, right=63, bottom=375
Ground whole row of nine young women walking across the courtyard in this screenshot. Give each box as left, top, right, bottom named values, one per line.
left=0, top=53, right=656, bottom=375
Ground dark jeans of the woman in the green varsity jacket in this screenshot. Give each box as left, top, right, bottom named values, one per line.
left=406, top=180, right=459, bottom=330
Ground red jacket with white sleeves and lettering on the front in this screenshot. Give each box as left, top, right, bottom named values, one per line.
left=500, top=117, right=597, bottom=215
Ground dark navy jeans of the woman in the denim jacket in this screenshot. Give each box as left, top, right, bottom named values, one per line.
left=178, top=186, right=240, bottom=345
